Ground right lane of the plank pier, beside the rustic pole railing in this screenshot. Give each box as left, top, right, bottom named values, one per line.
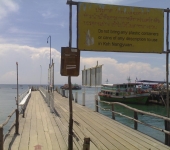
left=54, top=92, right=170, bottom=150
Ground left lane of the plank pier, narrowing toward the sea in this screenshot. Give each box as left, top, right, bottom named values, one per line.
left=4, top=91, right=67, bottom=150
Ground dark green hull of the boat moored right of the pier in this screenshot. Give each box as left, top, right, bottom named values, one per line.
left=99, top=94, right=149, bottom=104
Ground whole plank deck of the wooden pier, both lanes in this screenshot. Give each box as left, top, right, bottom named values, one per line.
left=4, top=91, right=170, bottom=150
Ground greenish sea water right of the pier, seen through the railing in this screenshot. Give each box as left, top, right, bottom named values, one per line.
left=73, top=88, right=167, bottom=143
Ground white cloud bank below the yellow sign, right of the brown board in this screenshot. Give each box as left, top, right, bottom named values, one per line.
left=81, top=58, right=165, bottom=83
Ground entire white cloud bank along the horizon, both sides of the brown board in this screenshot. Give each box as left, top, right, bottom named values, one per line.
left=0, top=44, right=165, bottom=84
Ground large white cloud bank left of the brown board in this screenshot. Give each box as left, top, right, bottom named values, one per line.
left=0, top=44, right=60, bottom=84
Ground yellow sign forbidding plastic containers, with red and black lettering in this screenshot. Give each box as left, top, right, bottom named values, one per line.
left=78, top=3, right=164, bottom=53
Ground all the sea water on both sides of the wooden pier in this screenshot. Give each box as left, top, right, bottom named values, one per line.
left=0, top=85, right=166, bottom=142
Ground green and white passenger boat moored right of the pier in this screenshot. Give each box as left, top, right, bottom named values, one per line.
left=98, top=83, right=150, bottom=104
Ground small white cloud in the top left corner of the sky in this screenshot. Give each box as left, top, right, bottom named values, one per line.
left=0, top=0, right=19, bottom=20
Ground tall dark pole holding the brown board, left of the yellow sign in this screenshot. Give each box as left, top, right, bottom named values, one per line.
left=68, top=0, right=73, bottom=150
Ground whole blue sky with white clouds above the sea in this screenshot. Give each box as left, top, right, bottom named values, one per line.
left=0, top=0, right=170, bottom=84
